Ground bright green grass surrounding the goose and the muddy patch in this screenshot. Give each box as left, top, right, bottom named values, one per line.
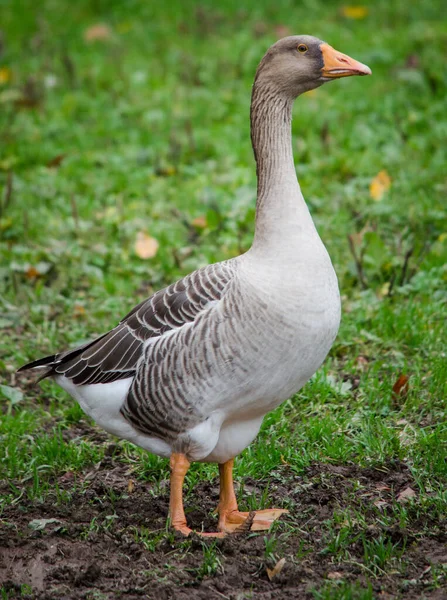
left=0, top=0, right=447, bottom=599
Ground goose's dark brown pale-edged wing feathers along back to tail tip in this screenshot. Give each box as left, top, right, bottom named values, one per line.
left=19, top=259, right=237, bottom=385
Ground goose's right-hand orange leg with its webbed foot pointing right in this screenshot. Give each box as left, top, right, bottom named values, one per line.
left=217, top=459, right=289, bottom=533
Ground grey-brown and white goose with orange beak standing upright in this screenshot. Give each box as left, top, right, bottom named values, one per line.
left=19, top=35, right=371, bottom=536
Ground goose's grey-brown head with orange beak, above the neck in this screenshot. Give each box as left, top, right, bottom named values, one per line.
left=255, top=35, right=371, bottom=98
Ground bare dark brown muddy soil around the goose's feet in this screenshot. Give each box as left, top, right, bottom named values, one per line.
left=0, top=448, right=447, bottom=600
